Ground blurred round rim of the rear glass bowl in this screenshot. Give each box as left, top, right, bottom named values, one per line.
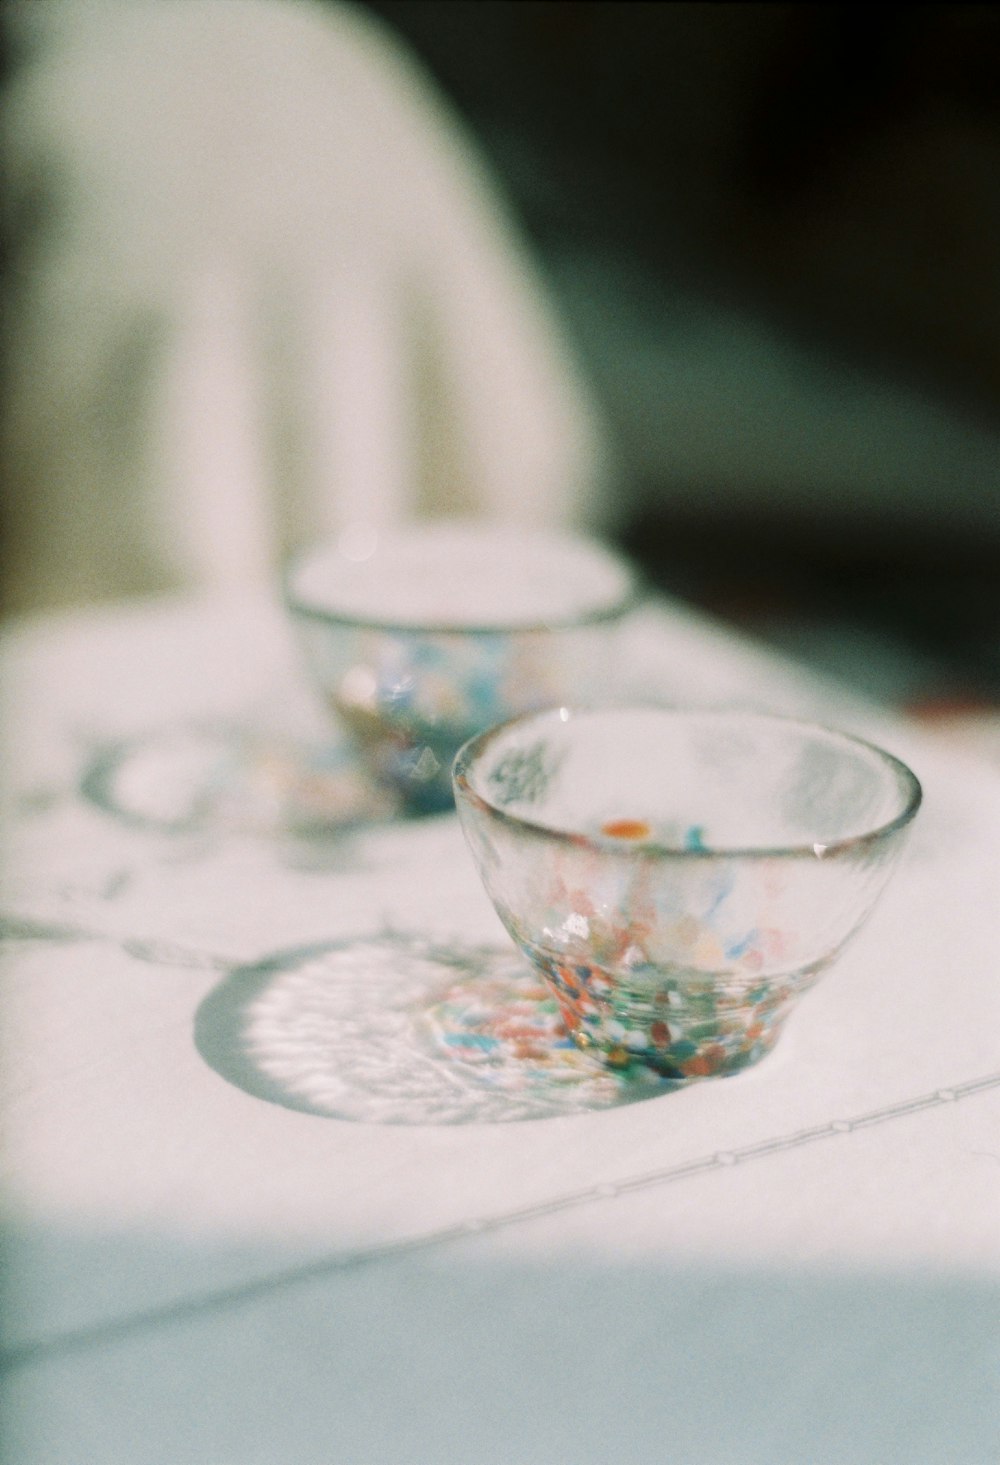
left=281, top=520, right=646, bottom=637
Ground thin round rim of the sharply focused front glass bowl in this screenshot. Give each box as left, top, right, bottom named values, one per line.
left=451, top=702, right=924, bottom=860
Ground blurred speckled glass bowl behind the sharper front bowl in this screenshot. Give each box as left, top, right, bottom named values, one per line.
left=286, top=520, right=637, bottom=812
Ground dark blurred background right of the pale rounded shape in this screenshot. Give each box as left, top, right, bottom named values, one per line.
left=0, top=0, right=1000, bottom=702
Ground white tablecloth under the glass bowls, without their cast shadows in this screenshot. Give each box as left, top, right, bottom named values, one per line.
left=0, top=588, right=1000, bottom=1465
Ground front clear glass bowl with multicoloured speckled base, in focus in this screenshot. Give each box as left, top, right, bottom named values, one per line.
left=454, top=708, right=921, bottom=1080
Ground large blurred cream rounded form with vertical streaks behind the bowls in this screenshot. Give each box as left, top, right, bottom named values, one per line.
left=4, top=0, right=608, bottom=607
